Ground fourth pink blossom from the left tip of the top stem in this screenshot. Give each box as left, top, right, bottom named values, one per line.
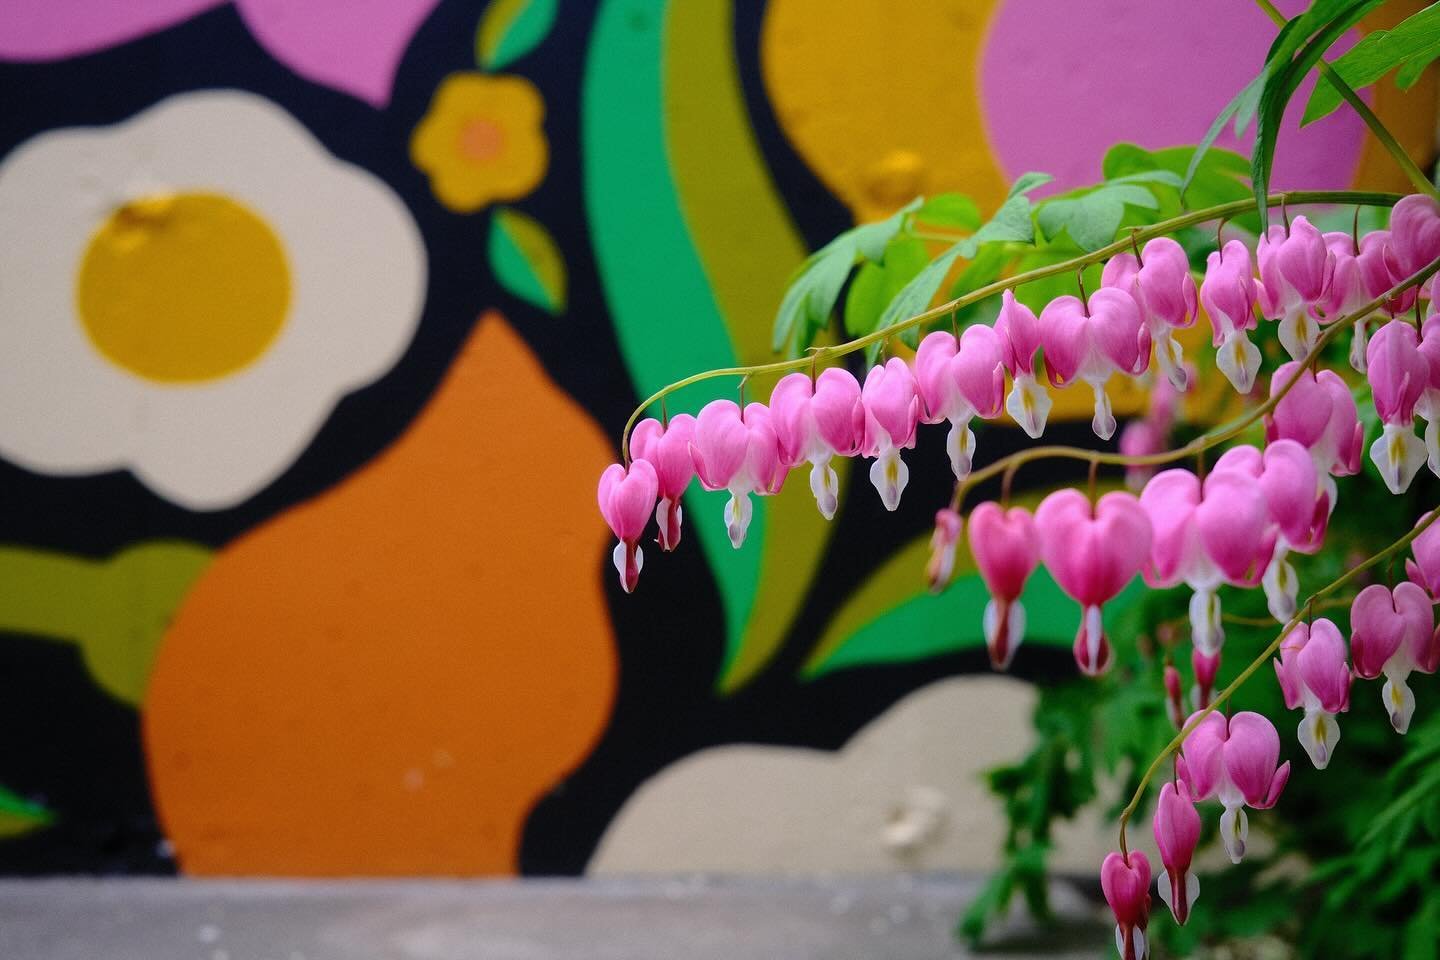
left=770, top=367, right=865, bottom=520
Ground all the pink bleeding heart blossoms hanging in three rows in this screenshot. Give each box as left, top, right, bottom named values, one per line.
left=599, top=196, right=1440, bottom=957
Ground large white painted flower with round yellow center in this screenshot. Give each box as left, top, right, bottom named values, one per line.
left=0, top=91, right=426, bottom=510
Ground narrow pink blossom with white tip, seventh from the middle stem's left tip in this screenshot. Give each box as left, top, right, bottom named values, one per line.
left=1365, top=320, right=1430, bottom=494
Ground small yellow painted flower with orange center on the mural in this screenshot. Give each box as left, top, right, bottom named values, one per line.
left=410, top=73, right=550, bottom=213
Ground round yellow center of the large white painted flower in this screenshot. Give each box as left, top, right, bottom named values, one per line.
left=75, top=193, right=291, bottom=383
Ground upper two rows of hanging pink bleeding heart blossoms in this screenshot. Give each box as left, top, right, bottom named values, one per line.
left=599, top=196, right=1440, bottom=604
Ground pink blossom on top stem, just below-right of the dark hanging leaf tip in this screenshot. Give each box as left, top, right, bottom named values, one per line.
left=1256, top=216, right=1335, bottom=360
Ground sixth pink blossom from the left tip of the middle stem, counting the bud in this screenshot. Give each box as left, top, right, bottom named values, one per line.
left=1266, top=360, right=1365, bottom=512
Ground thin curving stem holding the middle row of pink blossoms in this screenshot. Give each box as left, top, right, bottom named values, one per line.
left=950, top=251, right=1440, bottom=510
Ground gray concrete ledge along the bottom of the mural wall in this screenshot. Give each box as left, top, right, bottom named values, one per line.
left=0, top=875, right=1110, bottom=960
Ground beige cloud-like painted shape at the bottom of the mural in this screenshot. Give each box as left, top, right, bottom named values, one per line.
left=589, top=675, right=1111, bottom=874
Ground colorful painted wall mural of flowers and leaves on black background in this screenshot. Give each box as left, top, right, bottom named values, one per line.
left=0, top=0, right=1436, bottom=875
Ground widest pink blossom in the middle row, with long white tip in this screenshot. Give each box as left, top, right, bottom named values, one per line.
left=1139, top=469, right=1274, bottom=653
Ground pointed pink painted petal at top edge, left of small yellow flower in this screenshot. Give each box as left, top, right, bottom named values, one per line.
left=236, top=0, right=439, bottom=107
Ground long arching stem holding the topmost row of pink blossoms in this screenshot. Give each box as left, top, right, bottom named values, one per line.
left=621, top=190, right=1400, bottom=463
